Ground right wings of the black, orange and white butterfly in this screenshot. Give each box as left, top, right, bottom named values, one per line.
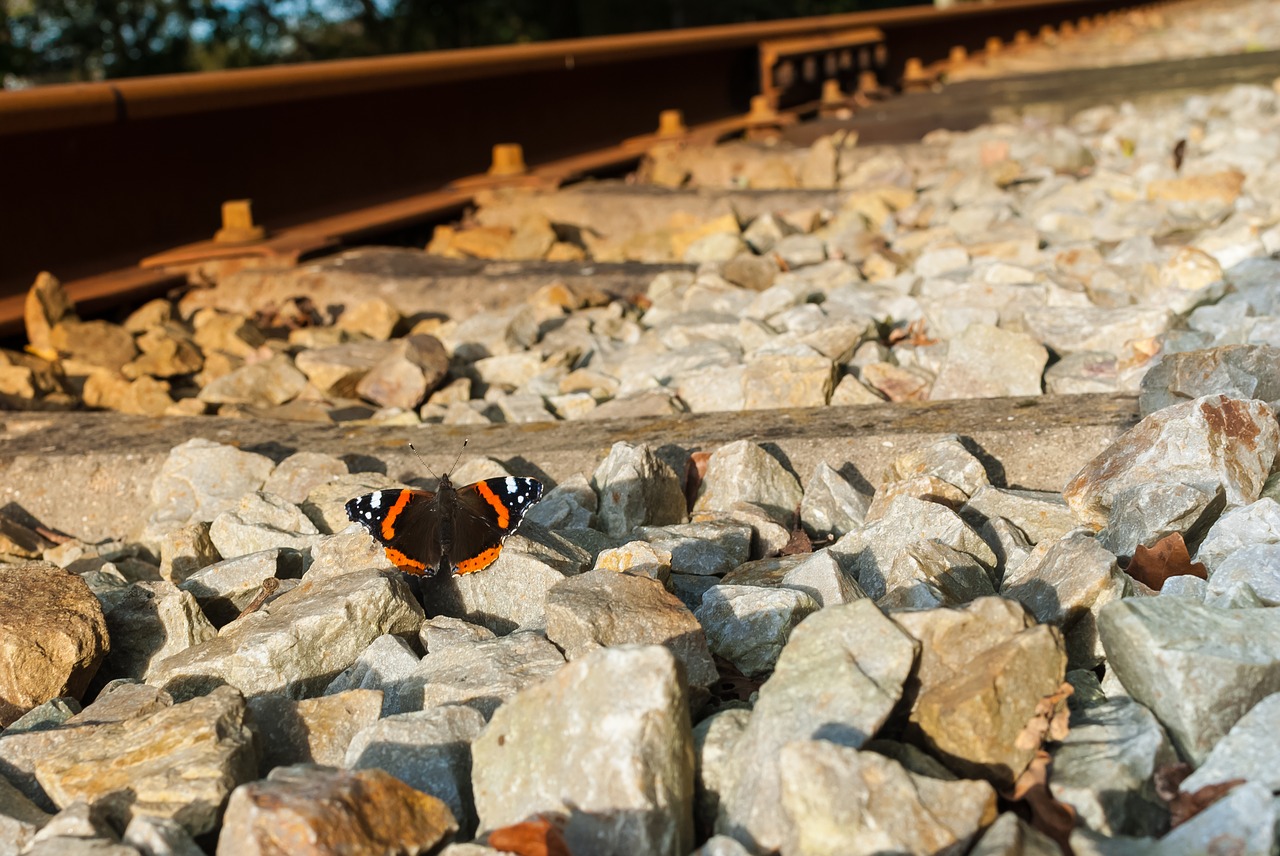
left=449, top=476, right=543, bottom=573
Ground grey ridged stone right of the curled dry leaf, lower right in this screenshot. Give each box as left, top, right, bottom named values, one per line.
left=1050, top=699, right=1178, bottom=836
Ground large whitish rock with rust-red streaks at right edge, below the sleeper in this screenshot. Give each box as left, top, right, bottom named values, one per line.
left=1062, top=395, right=1280, bottom=528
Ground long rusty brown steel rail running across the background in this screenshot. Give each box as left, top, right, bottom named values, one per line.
left=0, top=0, right=1137, bottom=331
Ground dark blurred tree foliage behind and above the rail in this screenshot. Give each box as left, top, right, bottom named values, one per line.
left=0, top=0, right=918, bottom=86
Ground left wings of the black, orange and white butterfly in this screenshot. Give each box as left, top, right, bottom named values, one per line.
left=346, top=490, right=440, bottom=576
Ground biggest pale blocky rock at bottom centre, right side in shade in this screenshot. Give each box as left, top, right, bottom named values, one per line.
left=472, top=645, right=694, bottom=856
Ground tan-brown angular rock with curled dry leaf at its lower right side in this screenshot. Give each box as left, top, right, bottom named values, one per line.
left=893, top=598, right=1066, bottom=788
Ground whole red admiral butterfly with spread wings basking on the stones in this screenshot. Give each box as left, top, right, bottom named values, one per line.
left=347, top=475, right=543, bottom=577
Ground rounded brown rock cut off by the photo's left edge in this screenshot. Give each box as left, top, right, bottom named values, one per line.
left=0, top=562, right=110, bottom=725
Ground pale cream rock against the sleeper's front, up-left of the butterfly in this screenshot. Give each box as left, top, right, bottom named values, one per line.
left=148, top=438, right=275, bottom=531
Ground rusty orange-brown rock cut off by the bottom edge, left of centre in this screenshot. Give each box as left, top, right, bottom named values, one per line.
left=218, top=765, right=458, bottom=856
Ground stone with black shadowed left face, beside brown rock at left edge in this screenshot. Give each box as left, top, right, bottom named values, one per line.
left=105, top=582, right=218, bottom=681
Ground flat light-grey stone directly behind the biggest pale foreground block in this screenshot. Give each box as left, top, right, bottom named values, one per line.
left=411, top=632, right=564, bottom=719
